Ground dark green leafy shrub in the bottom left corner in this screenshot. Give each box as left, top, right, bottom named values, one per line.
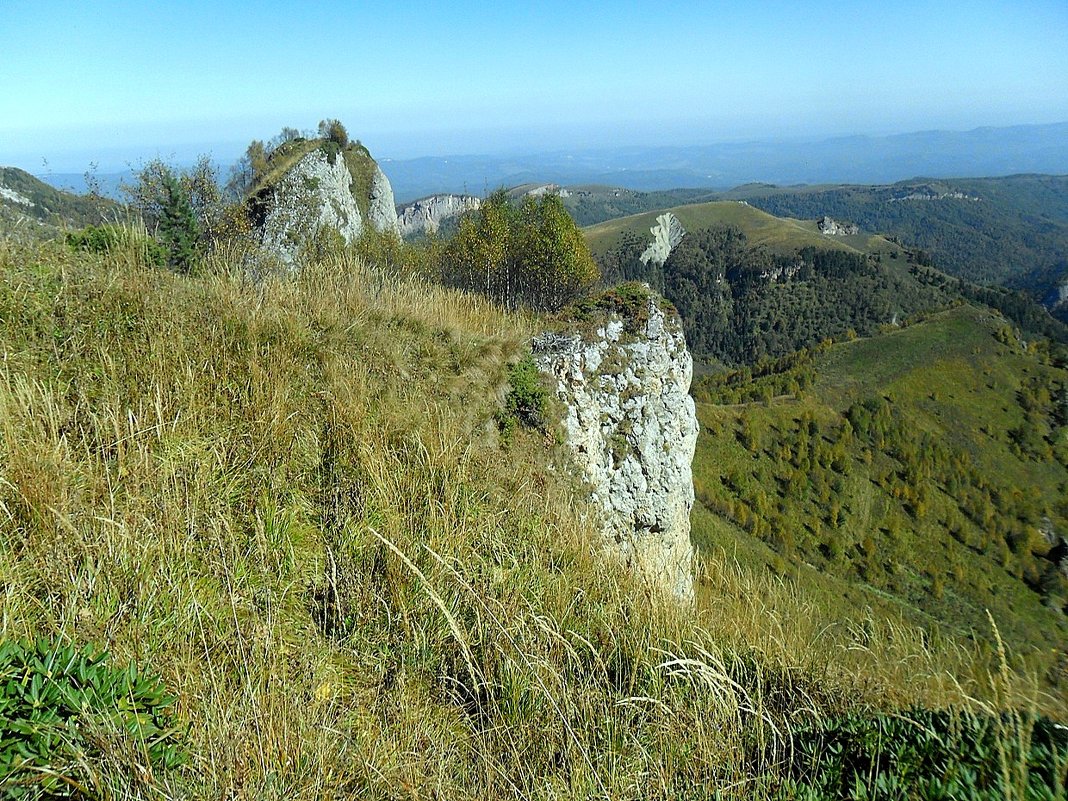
left=0, top=640, right=186, bottom=799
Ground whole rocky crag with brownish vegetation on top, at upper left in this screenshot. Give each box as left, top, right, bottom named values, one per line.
left=249, top=140, right=398, bottom=265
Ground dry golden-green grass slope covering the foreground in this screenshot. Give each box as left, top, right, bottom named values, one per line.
left=0, top=241, right=1059, bottom=800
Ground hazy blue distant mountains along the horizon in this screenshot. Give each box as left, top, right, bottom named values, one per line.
left=31, top=122, right=1068, bottom=203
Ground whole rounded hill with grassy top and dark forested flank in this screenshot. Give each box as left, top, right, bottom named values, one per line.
left=584, top=194, right=1068, bottom=363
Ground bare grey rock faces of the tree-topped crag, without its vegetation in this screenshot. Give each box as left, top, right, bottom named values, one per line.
left=258, top=148, right=397, bottom=265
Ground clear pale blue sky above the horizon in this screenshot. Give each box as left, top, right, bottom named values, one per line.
left=0, top=0, right=1068, bottom=172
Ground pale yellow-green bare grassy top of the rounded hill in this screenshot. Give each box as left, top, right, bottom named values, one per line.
left=584, top=201, right=899, bottom=260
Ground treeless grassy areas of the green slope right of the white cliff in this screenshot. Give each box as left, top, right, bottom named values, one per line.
left=694, top=307, right=1068, bottom=700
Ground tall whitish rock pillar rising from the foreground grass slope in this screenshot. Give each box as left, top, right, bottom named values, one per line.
left=534, top=297, right=697, bottom=601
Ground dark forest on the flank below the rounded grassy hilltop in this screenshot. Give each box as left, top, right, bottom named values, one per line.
left=601, top=226, right=958, bottom=364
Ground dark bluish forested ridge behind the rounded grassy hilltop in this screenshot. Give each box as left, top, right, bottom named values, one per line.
left=565, top=175, right=1068, bottom=326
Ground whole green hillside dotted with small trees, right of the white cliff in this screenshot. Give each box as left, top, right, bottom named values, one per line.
left=693, top=305, right=1068, bottom=692
